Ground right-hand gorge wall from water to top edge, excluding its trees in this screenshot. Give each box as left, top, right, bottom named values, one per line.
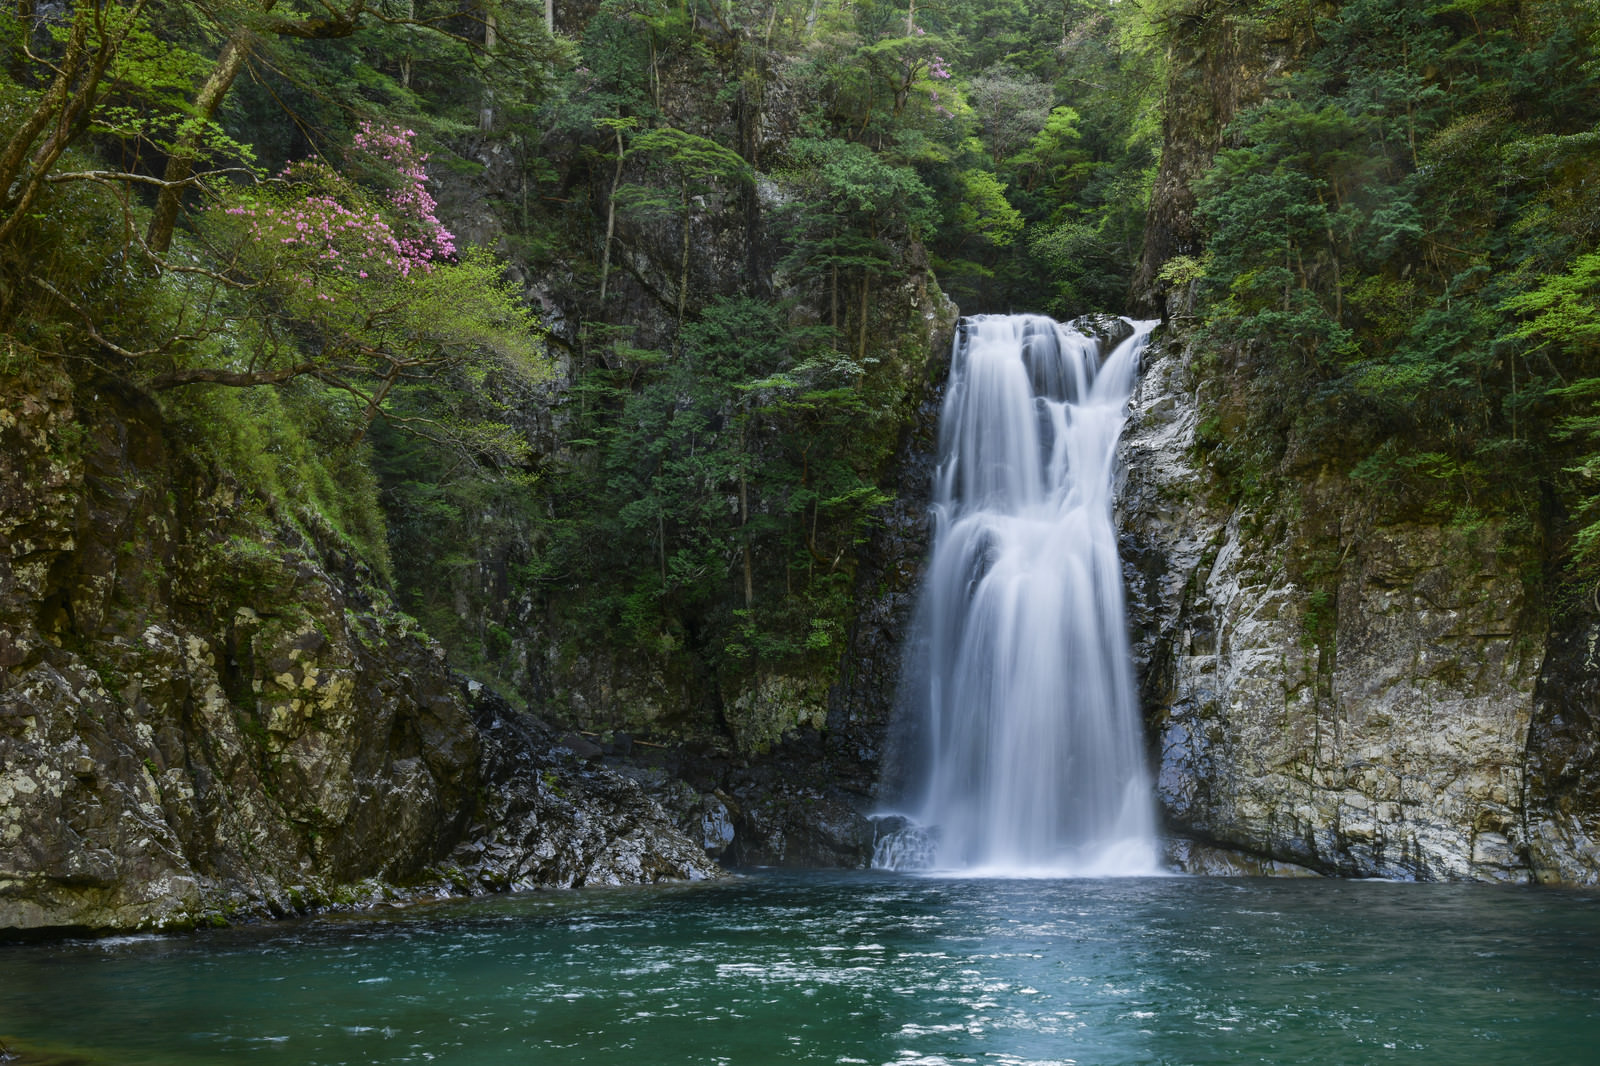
left=1122, top=3, right=1600, bottom=885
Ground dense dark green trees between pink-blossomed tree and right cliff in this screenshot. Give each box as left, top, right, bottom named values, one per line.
left=337, top=0, right=1157, bottom=723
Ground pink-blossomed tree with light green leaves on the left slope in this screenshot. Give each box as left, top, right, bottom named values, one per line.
left=152, top=123, right=547, bottom=451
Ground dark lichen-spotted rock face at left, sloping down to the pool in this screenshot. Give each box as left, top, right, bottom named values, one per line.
left=0, top=364, right=712, bottom=930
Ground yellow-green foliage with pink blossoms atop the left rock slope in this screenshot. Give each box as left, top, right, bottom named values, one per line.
left=0, top=3, right=547, bottom=598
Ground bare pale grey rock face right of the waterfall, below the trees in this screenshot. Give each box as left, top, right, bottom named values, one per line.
left=1120, top=332, right=1600, bottom=884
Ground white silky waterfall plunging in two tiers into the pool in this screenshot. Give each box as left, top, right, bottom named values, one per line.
left=874, top=315, right=1157, bottom=876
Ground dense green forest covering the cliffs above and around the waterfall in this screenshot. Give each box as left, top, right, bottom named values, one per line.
left=0, top=0, right=1600, bottom=746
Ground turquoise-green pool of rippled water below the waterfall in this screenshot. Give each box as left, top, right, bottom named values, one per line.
left=0, top=872, right=1600, bottom=1066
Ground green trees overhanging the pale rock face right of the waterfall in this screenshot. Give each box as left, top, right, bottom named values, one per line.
left=1186, top=0, right=1600, bottom=589
